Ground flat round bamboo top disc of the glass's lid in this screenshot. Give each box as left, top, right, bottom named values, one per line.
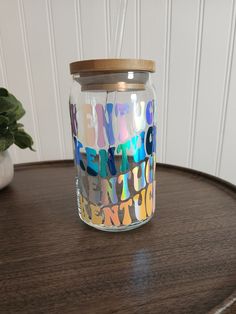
left=70, top=59, right=155, bottom=75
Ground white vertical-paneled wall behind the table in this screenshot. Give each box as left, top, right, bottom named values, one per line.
left=0, top=0, right=236, bottom=183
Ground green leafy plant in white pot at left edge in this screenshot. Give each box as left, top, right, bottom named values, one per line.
left=0, top=87, right=33, bottom=189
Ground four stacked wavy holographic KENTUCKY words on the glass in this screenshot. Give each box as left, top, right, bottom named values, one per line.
left=70, top=100, right=156, bottom=227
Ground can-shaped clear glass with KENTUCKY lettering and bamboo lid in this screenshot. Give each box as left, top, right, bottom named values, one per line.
left=70, top=59, right=157, bottom=231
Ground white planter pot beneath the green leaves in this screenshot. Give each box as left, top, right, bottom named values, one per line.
left=0, top=151, right=14, bottom=189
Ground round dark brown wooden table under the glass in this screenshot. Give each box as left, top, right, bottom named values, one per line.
left=0, top=161, right=236, bottom=314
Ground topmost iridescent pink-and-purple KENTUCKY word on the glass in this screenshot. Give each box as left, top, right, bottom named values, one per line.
left=70, top=100, right=155, bottom=148
